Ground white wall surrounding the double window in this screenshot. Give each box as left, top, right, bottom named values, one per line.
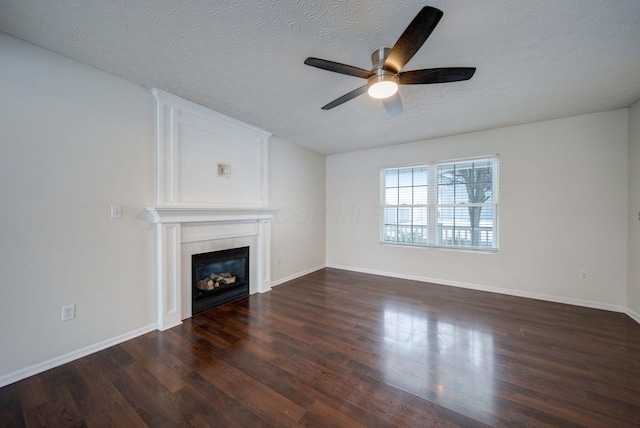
left=326, top=109, right=627, bottom=311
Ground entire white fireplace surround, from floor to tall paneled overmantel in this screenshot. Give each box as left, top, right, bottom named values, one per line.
left=147, top=89, right=275, bottom=330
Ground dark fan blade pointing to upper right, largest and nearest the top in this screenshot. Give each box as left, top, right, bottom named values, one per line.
left=384, top=6, right=443, bottom=73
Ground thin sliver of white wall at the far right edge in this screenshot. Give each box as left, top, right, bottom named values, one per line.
left=627, top=100, right=640, bottom=322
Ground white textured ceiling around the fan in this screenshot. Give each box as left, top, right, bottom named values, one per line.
left=0, top=0, right=640, bottom=154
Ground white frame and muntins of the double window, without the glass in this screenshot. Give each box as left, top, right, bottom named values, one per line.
left=380, top=155, right=500, bottom=253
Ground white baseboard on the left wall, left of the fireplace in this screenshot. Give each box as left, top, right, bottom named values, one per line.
left=0, top=324, right=157, bottom=388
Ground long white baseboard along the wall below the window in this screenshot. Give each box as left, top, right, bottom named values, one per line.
left=327, top=264, right=628, bottom=312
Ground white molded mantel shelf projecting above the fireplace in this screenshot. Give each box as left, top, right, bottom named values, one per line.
left=147, top=207, right=277, bottom=223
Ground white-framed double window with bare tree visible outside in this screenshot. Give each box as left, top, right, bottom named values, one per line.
left=381, top=156, right=498, bottom=250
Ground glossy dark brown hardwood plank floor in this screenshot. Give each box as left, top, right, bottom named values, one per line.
left=0, top=269, right=640, bottom=427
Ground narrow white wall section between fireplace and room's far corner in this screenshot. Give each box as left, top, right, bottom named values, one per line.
left=269, top=137, right=326, bottom=285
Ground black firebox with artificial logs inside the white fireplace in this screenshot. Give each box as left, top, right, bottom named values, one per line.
left=191, top=247, right=249, bottom=315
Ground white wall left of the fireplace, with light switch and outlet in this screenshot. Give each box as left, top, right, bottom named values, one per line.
left=0, top=33, right=155, bottom=385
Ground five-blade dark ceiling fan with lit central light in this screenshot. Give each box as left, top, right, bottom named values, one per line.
left=304, top=6, right=476, bottom=116
